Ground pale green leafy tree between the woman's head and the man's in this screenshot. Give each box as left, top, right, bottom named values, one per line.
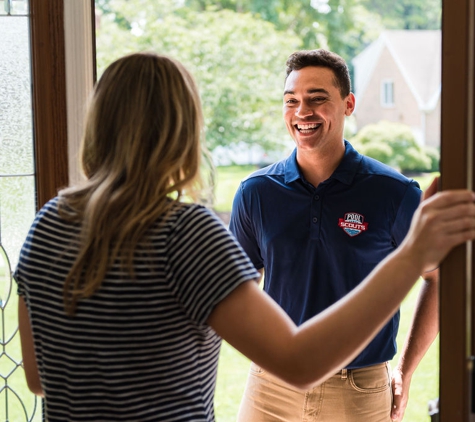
left=97, top=0, right=300, bottom=151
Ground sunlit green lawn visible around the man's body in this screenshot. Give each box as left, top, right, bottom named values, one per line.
left=215, top=166, right=439, bottom=422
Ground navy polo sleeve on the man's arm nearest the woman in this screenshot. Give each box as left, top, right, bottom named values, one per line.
left=229, top=182, right=264, bottom=269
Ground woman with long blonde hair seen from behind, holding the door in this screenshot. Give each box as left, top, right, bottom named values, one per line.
left=15, top=53, right=475, bottom=422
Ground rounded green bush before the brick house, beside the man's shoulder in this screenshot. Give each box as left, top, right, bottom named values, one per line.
left=350, top=121, right=438, bottom=172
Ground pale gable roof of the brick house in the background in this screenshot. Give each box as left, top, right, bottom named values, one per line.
left=352, top=30, right=442, bottom=110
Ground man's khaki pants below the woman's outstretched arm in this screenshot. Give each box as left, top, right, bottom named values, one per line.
left=237, top=363, right=392, bottom=422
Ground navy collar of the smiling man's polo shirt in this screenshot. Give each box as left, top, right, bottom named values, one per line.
left=285, top=140, right=363, bottom=185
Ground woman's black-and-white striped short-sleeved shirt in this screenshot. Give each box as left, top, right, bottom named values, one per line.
left=14, top=198, right=258, bottom=422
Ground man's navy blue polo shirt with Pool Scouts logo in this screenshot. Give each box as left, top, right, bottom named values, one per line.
left=230, top=141, right=421, bottom=368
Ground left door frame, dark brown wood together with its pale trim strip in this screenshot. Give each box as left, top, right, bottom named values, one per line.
left=29, top=0, right=96, bottom=209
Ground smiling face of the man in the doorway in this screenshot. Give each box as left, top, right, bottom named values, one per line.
left=283, top=66, right=355, bottom=150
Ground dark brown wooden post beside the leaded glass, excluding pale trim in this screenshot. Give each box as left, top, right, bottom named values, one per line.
left=30, top=0, right=68, bottom=209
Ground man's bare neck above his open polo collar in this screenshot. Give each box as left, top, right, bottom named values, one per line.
left=297, top=143, right=345, bottom=187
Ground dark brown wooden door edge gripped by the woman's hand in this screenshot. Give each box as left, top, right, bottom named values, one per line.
left=439, top=0, right=475, bottom=422
